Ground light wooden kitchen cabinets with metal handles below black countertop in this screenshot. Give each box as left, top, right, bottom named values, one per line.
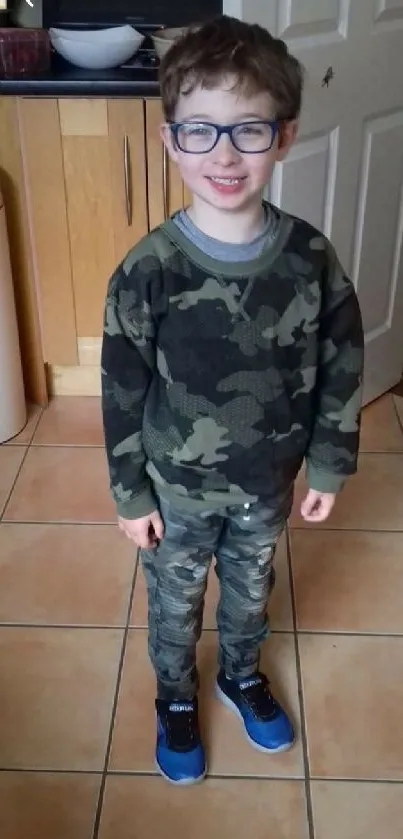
left=0, top=97, right=188, bottom=403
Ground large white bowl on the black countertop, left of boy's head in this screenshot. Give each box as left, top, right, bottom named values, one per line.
left=49, top=26, right=145, bottom=70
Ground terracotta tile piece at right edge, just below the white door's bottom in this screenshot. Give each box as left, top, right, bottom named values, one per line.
left=360, top=393, right=403, bottom=452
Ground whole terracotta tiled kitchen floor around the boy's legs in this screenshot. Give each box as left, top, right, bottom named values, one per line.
left=0, top=395, right=403, bottom=839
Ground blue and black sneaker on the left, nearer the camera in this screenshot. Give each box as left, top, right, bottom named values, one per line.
left=155, top=699, right=206, bottom=785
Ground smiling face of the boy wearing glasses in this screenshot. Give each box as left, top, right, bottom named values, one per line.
left=162, top=79, right=297, bottom=217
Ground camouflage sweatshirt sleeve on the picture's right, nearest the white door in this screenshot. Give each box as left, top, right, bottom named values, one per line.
left=306, top=243, right=364, bottom=492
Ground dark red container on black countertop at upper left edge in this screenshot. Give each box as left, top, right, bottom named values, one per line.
left=0, top=27, right=50, bottom=79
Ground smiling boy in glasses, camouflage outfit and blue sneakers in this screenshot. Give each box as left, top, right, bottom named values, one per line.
left=102, top=16, right=363, bottom=784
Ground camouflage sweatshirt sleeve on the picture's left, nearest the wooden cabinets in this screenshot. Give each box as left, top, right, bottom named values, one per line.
left=101, top=255, right=157, bottom=519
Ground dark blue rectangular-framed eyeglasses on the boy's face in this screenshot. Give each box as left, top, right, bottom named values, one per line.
left=168, top=120, right=279, bottom=154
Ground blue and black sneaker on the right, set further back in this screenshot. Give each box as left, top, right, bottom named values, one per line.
left=216, top=670, right=294, bottom=754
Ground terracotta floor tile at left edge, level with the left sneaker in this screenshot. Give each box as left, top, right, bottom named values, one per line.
left=0, top=627, right=123, bottom=771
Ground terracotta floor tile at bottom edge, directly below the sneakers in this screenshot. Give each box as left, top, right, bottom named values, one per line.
left=99, top=776, right=308, bottom=839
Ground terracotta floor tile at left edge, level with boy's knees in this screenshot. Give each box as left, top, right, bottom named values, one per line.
left=0, top=524, right=136, bottom=626
